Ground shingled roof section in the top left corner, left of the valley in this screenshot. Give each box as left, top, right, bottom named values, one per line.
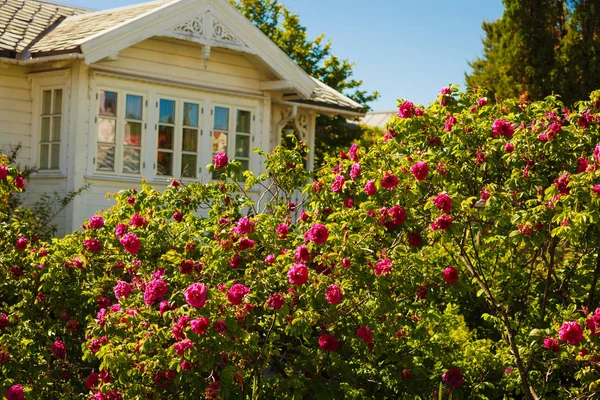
left=0, top=0, right=90, bottom=58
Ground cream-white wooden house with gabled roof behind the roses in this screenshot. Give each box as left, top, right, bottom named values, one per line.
left=0, top=0, right=363, bottom=234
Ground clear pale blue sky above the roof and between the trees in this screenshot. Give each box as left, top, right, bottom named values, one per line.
left=60, top=0, right=504, bottom=110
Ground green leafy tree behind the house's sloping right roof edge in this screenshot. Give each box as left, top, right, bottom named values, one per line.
left=231, top=0, right=379, bottom=162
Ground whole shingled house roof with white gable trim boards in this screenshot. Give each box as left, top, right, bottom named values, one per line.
left=0, top=0, right=363, bottom=115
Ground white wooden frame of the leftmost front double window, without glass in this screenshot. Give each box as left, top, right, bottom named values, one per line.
left=96, top=85, right=149, bottom=178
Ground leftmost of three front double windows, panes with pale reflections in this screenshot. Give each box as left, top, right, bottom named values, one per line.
left=96, top=90, right=144, bottom=175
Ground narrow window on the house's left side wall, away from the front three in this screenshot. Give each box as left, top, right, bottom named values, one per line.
left=39, top=89, right=63, bottom=170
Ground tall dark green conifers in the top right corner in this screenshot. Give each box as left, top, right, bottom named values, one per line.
left=466, top=0, right=600, bottom=104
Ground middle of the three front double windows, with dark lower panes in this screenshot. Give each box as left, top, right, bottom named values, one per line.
left=156, top=99, right=201, bottom=179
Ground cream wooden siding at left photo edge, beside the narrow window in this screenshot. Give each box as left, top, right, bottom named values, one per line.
left=0, top=64, right=31, bottom=165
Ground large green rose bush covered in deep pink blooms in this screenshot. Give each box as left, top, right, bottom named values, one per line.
left=0, top=87, right=600, bottom=399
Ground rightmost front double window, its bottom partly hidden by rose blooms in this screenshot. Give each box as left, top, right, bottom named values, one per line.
left=212, top=106, right=252, bottom=179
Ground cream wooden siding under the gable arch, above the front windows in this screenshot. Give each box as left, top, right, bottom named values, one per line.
left=94, top=38, right=267, bottom=93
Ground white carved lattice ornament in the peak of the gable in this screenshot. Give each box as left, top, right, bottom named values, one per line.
left=164, top=11, right=251, bottom=52
